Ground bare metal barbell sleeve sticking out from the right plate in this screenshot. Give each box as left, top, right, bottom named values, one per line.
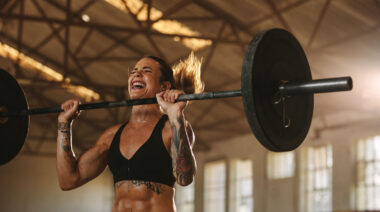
left=278, top=77, right=352, bottom=95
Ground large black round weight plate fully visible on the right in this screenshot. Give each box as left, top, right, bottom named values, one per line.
left=242, top=29, right=314, bottom=152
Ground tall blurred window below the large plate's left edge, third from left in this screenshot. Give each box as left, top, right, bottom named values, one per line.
left=229, top=159, right=253, bottom=212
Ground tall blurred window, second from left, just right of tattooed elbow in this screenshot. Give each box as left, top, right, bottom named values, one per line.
left=203, top=160, right=227, bottom=212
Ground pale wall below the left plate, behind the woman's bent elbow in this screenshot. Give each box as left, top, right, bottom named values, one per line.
left=0, top=154, right=113, bottom=212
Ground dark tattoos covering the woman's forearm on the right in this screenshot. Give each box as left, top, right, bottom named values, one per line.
left=171, top=116, right=195, bottom=185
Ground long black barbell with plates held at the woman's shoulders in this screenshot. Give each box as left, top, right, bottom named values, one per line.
left=0, top=29, right=352, bottom=165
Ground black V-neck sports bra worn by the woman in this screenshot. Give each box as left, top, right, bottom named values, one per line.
left=108, top=115, right=175, bottom=187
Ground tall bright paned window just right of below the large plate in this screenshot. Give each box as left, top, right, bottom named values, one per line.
left=300, top=145, right=333, bottom=212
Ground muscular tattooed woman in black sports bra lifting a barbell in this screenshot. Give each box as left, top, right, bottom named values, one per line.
left=57, top=54, right=203, bottom=212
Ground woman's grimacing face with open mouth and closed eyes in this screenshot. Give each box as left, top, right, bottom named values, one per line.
left=128, top=58, right=164, bottom=99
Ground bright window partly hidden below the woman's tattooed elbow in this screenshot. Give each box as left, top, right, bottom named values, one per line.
left=175, top=181, right=195, bottom=212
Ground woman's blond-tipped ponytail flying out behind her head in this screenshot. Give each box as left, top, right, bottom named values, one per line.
left=146, top=52, right=204, bottom=94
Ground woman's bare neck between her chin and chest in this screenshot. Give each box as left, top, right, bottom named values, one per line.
left=129, top=105, right=162, bottom=124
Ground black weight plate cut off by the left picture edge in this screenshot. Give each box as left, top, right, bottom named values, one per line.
left=0, top=69, right=29, bottom=165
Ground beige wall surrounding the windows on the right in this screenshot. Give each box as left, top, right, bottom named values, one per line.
left=195, top=113, right=380, bottom=212
